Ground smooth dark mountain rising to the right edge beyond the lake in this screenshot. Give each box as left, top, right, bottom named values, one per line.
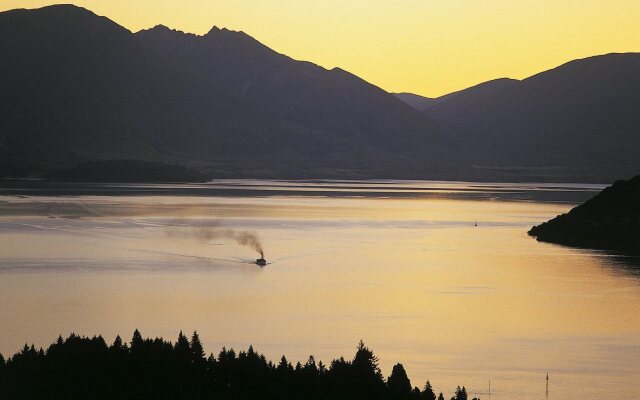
left=426, top=53, right=640, bottom=182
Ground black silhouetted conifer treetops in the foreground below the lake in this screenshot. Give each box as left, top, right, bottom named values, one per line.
left=0, top=330, right=479, bottom=400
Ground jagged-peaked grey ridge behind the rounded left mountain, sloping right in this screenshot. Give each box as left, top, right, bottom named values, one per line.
left=136, top=25, right=480, bottom=173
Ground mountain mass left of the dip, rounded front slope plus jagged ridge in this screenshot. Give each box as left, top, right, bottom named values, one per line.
left=0, top=6, right=480, bottom=176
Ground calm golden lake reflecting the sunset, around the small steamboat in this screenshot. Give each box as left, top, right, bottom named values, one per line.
left=0, top=180, right=640, bottom=399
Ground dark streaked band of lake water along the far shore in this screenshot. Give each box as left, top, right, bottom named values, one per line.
left=0, top=179, right=604, bottom=204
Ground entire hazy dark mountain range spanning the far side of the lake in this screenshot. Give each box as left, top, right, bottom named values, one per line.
left=0, top=6, right=640, bottom=181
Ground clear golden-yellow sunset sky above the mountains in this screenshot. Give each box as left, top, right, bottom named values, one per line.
left=0, top=0, right=640, bottom=97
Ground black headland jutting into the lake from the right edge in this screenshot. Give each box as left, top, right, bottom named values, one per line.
left=529, top=175, right=640, bottom=254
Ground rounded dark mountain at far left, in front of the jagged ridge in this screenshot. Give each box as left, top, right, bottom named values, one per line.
left=0, top=6, right=376, bottom=177
